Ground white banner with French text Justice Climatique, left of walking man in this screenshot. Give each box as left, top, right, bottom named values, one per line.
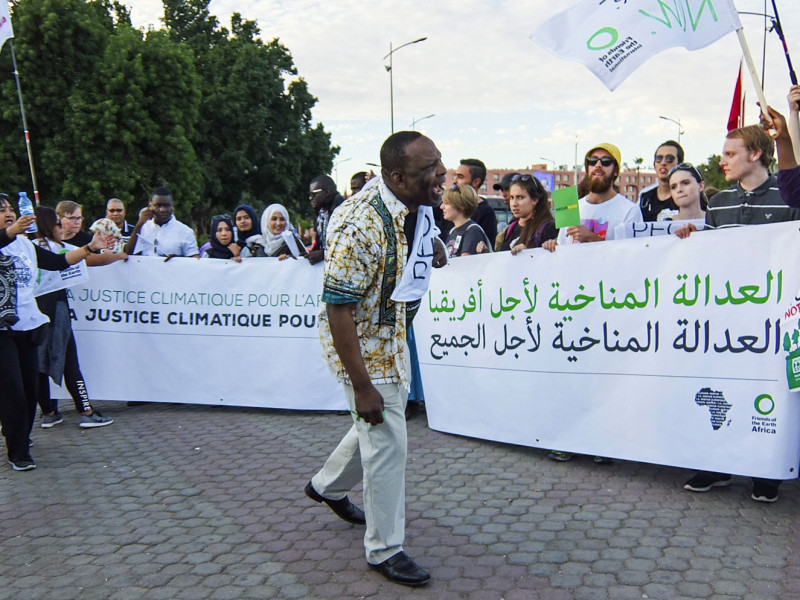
left=53, top=256, right=347, bottom=410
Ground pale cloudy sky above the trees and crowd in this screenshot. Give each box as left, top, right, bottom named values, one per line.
left=125, top=0, right=800, bottom=190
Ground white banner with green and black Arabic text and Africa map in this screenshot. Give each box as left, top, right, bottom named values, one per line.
left=414, top=223, right=800, bottom=479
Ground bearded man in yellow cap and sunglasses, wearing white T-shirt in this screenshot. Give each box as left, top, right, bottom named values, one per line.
left=542, top=143, right=642, bottom=252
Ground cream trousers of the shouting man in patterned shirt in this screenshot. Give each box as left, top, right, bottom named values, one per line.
left=311, top=383, right=408, bottom=564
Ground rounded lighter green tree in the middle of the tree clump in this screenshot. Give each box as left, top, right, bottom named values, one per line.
left=58, top=25, right=203, bottom=219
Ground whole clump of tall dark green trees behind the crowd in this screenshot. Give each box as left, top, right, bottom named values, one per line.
left=0, top=0, right=338, bottom=230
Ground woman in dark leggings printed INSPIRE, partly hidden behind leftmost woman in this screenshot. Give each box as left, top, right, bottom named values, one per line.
left=36, top=206, right=113, bottom=429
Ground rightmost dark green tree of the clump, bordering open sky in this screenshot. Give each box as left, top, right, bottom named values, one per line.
left=164, top=0, right=338, bottom=225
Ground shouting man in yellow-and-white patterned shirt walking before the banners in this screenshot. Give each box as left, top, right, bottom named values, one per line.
left=305, top=131, right=447, bottom=586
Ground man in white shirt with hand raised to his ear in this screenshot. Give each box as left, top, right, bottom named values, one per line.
left=125, top=187, right=200, bottom=258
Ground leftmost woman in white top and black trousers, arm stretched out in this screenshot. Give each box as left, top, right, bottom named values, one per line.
left=0, top=194, right=113, bottom=471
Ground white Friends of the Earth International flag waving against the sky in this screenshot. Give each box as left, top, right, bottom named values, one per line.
left=531, top=0, right=742, bottom=90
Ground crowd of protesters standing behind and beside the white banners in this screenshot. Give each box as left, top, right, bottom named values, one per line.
left=0, top=86, right=800, bottom=502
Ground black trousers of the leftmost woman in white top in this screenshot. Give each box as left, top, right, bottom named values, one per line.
left=0, top=325, right=47, bottom=461
